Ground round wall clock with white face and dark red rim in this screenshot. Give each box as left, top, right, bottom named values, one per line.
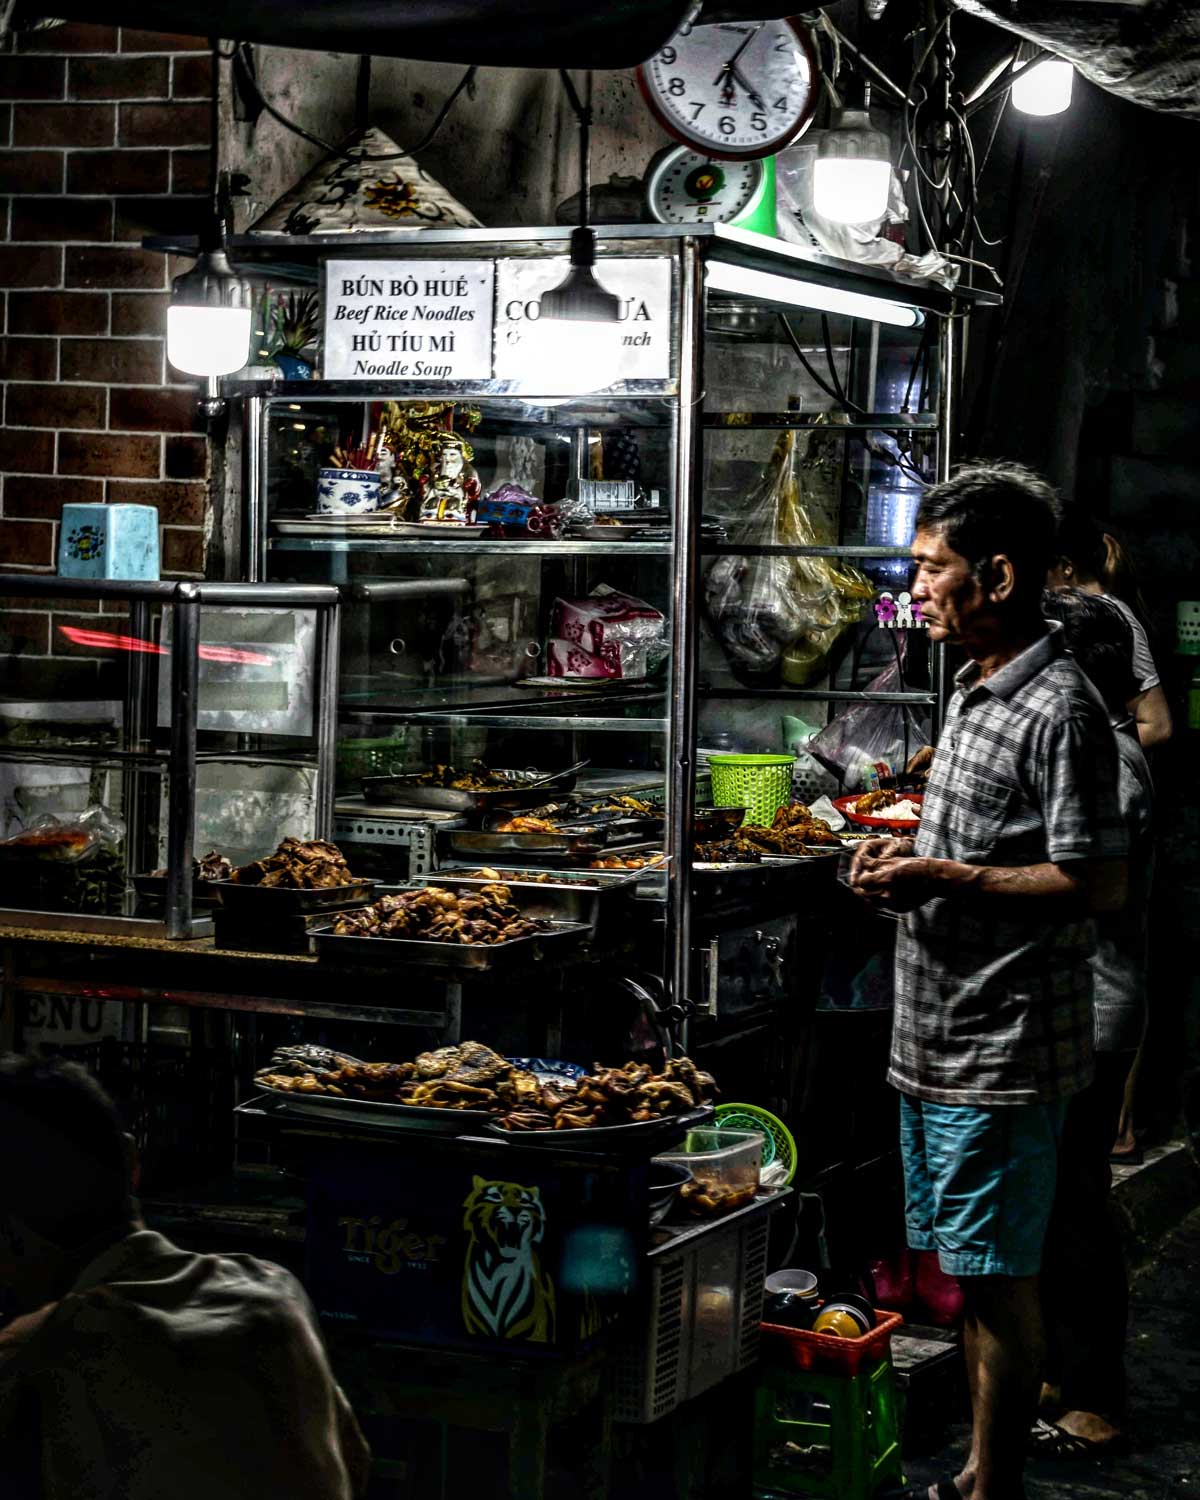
left=638, top=20, right=816, bottom=161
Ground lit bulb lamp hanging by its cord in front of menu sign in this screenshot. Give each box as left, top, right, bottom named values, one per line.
left=527, top=69, right=623, bottom=396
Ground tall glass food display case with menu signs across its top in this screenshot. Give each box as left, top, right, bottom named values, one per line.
left=230, top=225, right=981, bottom=1007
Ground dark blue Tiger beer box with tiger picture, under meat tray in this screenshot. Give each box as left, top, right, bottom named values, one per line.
left=306, top=1137, right=648, bottom=1356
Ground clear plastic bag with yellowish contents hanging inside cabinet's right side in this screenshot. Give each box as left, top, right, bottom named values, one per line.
left=705, top=432, right=875, bottom=687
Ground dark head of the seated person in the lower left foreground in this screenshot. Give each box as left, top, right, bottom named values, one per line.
left=0, top=1056, right=137, bottom=1307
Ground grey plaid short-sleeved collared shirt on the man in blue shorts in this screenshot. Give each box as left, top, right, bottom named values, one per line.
left=888, top=626, right=1128, bottom=1106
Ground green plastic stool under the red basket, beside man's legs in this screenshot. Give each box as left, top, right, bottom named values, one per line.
left=755, top=1356, right=905, bottom=1500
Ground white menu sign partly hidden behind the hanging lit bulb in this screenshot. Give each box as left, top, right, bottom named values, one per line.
left=495, top=255, right=671, bottom=381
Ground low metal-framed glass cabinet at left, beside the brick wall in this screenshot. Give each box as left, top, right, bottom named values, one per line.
left=0, top=575, right=341, bottom=939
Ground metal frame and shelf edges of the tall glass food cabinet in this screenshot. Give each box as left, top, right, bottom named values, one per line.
left=234, top=225, right=972, bottom=1020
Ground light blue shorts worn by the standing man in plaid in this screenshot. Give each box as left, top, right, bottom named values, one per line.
left=900, top=1094, right=1067, bottom=1277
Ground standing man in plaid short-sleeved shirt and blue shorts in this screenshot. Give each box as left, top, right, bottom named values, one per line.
left=852, top=464, right=1127, bottom=1500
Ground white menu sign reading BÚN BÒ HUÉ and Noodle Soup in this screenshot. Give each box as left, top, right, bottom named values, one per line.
left=323, top=260, right=495, bottom=381
